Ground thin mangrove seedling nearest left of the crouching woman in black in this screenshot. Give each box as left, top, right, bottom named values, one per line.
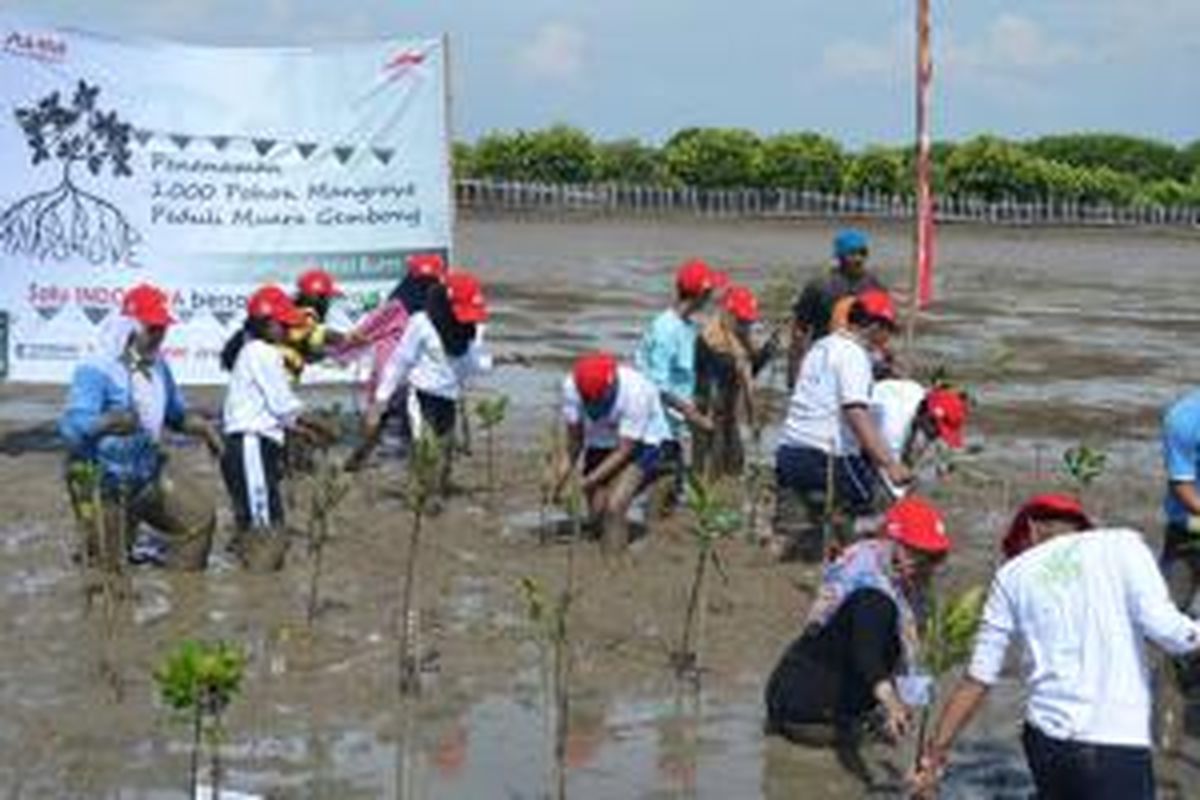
left=672, top=476, right=742, bottom=680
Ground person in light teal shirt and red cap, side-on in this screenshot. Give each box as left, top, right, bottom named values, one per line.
left=634, top=259, right=725, bottom=512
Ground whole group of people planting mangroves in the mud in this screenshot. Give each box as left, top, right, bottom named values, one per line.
left=60, top=230, right=1200, bottom=800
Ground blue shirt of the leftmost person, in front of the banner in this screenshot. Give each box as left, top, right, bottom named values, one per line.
left=59, top=359, right=185, bottom=491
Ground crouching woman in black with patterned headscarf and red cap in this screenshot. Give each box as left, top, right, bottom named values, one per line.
left=766, top=497, right=950, bottom=780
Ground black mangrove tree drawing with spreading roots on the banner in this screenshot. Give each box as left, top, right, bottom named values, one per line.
left=0, top=80, right=140, bottom=264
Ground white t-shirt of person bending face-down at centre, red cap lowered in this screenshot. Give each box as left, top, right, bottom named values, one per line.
left=563, top=367, right=672, bottom=450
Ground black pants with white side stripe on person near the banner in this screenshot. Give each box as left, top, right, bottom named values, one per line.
left=221, top=433, right=284, bottom=530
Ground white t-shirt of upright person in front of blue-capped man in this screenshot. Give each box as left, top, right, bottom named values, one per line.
left=780, top=331, right=874, bottom=456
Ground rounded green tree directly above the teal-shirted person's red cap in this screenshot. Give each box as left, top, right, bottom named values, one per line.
left=662, top=128, right=760, bottom=188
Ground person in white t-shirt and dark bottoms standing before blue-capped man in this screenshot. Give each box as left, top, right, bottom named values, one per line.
left=775, top=289, right=912, bottom=560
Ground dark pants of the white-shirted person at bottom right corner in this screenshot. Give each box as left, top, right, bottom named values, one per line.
left=1021, top=723, right=1154, bottom=800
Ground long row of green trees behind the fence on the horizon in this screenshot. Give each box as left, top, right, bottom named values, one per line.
left=454, top=125, right=1200, bottom=206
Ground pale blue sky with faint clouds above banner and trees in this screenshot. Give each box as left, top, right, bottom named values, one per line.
left=0, top=0, right=1200, bottom=148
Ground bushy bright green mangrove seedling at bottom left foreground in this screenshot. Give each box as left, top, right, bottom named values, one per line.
left=154, top=639, right=246, bottom=799
